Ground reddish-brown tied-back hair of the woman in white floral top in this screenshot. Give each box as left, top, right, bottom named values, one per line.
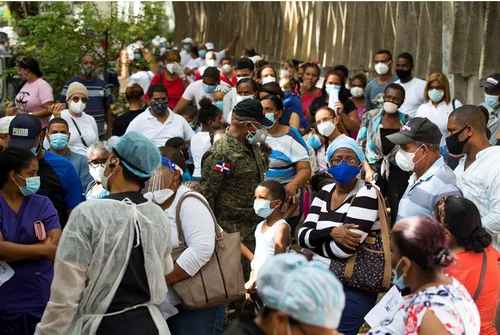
left=392, top=216, right=453, bottom=272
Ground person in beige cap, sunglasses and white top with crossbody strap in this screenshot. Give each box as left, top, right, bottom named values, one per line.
left=54, top=82, right=99, bottom=156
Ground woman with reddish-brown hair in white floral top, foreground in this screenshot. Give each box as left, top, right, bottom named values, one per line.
left=369, top=217, right=482, bottom=335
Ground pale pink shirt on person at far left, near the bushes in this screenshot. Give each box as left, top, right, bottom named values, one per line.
left=16, top=78, right=54, bottom=127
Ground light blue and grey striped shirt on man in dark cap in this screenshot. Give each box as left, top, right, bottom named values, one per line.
left=397, top=157, right=462, bottom=220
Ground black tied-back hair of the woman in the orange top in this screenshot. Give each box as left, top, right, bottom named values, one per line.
left=442, top=196, right=492, bottom=252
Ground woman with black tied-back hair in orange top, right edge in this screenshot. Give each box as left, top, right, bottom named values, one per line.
left=436, top=196, right=500, bottom=335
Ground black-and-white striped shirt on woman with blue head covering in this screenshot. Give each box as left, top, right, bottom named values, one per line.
left=298, top=180, right=380, bottom=258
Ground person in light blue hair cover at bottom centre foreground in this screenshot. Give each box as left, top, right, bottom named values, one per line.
left=224, top=254, right=345, bottom=335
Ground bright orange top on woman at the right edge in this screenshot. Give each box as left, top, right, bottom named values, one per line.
left=445, top=245, right=500, bottom=335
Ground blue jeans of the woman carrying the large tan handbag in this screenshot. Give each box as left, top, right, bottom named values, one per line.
left=167, top=306, right=224, bottom=335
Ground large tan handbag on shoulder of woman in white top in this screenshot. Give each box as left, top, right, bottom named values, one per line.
left=172, top=192, right=245, bottom=309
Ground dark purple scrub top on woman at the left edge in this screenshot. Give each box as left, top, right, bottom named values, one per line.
left=0, top=194, right=61, bottom=317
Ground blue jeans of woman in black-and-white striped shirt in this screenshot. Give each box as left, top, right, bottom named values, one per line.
left=338, top=286, right=377, bottom=335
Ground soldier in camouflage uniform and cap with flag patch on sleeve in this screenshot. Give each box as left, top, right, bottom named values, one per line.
left=200, top=99, right=272, bottom=268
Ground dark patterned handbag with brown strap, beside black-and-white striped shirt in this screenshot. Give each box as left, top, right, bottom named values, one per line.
left=330, top=186, right=392, bottom=293
